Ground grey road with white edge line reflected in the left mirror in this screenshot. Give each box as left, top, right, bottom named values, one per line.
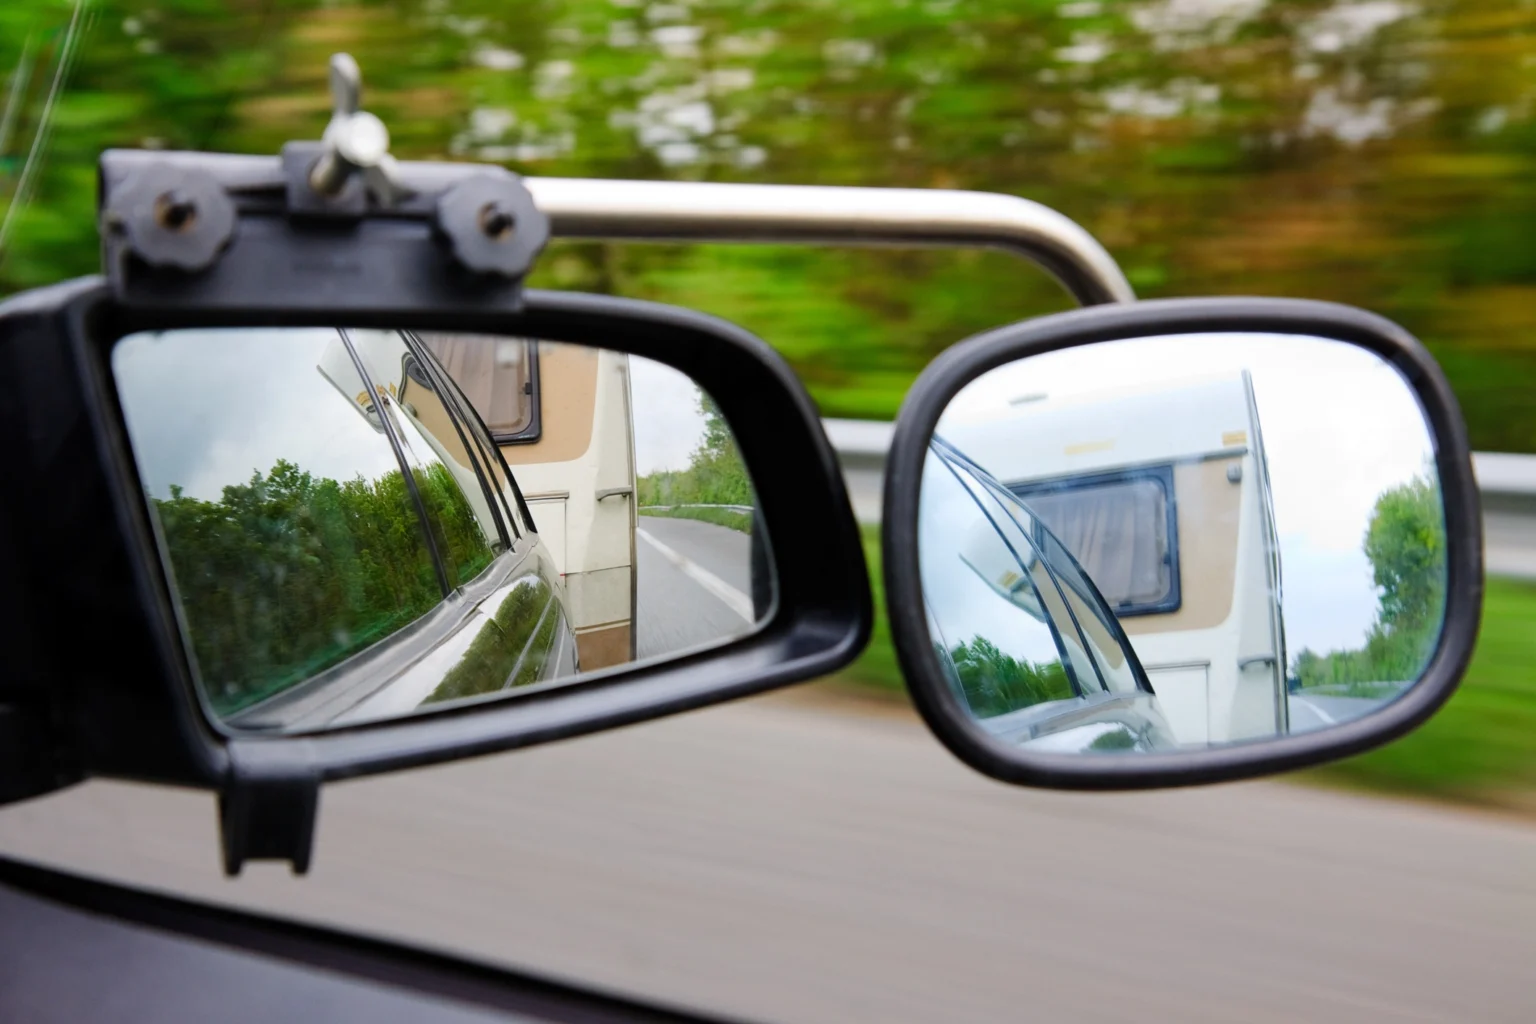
left=634, top=516, right=751, bottom=657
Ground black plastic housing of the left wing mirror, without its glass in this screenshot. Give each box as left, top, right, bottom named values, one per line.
left=0, top=276, right=871, bottom=870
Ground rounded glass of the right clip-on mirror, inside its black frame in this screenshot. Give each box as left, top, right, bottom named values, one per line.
left=919, top=333, right=1445, bottom=754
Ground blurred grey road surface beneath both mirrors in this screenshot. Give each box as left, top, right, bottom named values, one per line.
left=0, top=691, right=1536, bottom=1024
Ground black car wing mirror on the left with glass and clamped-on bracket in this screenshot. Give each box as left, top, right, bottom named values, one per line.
left=0, top=150, right=871, bottom=872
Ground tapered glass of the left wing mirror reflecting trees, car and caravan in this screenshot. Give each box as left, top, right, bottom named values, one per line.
left=112, top=327, right=774, bottom=732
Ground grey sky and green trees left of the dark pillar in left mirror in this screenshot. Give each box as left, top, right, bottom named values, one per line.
left=114, top=329, right=442, bottom=714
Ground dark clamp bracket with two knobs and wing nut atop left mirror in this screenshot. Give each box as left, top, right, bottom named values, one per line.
left=100, top=54, right=550, bottom=310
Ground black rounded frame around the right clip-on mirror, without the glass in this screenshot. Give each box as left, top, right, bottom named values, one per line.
left=882, top=298, right=1484, bottom=791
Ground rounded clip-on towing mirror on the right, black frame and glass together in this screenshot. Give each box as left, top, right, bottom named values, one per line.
left=883, top=299, right=1482, bottom=789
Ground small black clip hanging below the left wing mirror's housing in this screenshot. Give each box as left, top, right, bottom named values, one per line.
left=218, top=740, right=321, bottom=877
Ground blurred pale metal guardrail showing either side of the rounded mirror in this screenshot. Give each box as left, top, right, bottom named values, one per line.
left=822, top=419, right=1536, bottom=579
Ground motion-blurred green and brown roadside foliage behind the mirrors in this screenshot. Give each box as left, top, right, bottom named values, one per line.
left=9, top=0, right=1536, bottom=803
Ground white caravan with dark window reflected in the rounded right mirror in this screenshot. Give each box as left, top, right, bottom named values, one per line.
left=942, top=373, right=1287, bottom=745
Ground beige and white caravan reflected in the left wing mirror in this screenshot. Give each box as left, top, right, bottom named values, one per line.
left=422, top=333, right=634, bottom=671
